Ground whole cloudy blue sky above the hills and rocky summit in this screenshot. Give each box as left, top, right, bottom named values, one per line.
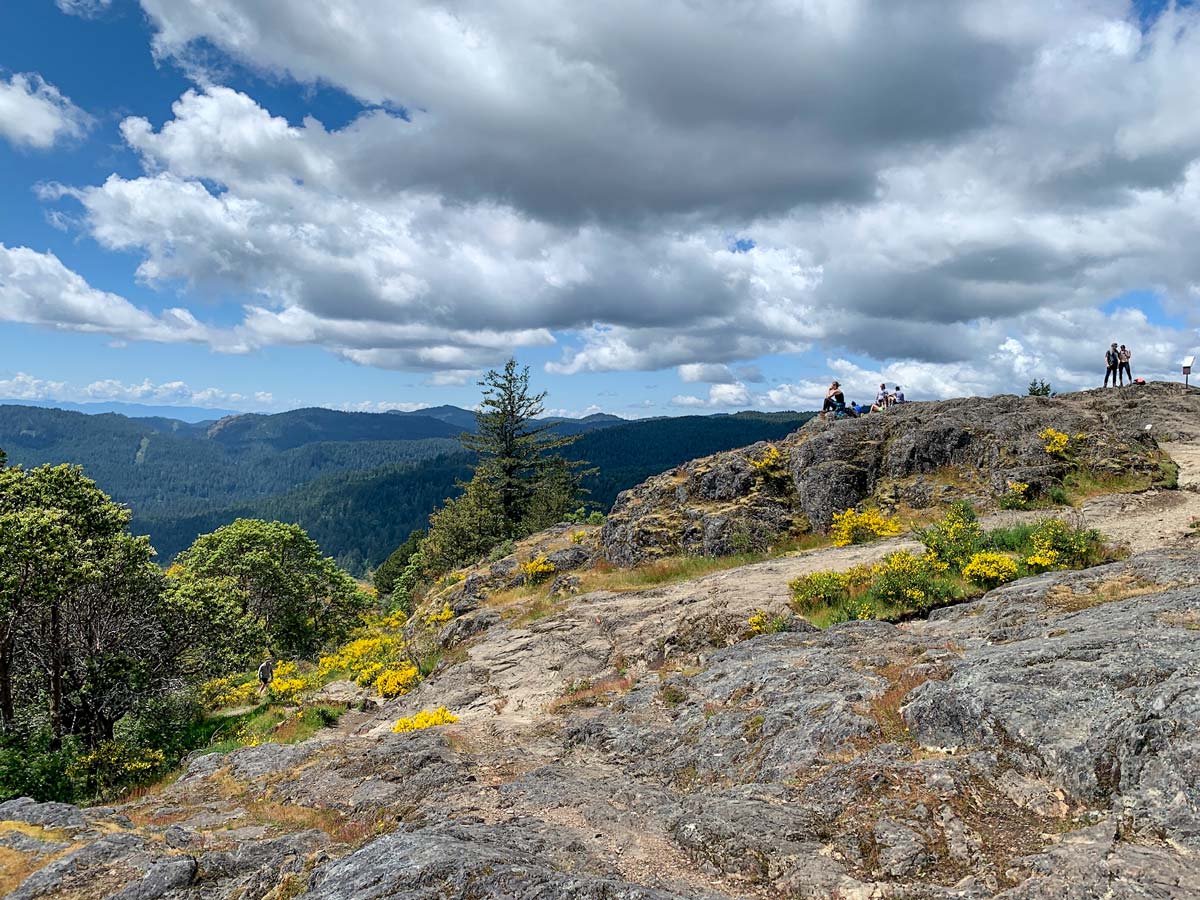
left=0, top=0, right=1200, bottom=416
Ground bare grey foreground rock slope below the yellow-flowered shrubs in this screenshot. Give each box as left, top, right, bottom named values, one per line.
left=9, top=548, right=1200, bottom=900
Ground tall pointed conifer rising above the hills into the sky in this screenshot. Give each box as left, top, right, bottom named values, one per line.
left=460, top=359, right=583, bottom=538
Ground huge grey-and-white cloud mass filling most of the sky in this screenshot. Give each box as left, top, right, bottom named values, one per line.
left=25, top=0, right=1200, bottom=393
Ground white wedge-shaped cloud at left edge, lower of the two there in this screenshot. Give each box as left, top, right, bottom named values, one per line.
left=0, top=244, right=224, bottom=343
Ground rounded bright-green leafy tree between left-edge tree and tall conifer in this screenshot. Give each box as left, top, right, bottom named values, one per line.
left=175, top=518, right=370, bottom=656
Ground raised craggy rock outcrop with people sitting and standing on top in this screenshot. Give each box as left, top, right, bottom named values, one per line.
left=601, top=384, right=1200, bottom=566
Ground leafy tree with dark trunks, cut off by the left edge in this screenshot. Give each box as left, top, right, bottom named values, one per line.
left=0, top=466, right=170, bottom=749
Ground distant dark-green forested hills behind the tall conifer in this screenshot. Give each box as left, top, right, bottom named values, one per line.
left=0, top=406, right=808, bottom=574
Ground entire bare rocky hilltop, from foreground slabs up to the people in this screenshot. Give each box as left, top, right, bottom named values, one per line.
left=0, top=385, right=1200, bottom=900
